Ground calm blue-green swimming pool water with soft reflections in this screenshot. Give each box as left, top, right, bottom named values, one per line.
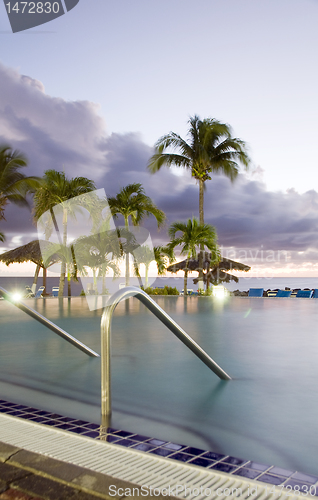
left=0, top=297, right=318, bottom=474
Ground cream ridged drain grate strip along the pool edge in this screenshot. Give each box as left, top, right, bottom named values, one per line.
left=0, top=414, right=310, bottom=500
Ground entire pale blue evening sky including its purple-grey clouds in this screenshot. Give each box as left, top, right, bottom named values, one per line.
left=0, top=0, right=318, bottom=276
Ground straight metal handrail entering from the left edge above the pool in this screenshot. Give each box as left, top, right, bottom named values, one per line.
left=0, top=287, right=99, bottom=358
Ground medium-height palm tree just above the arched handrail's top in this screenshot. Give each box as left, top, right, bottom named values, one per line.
left=108, top=183, right=165, bottom=286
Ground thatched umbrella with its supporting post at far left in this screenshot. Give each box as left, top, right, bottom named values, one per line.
left=0, top=240, right=61, bottom=293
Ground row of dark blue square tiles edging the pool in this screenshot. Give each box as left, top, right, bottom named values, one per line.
left=0, top=400, right=318, bottom=496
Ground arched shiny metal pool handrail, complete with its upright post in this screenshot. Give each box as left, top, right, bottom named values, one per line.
left=101, top=286, right=231, bottom=418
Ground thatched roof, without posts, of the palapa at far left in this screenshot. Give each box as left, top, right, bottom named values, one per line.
left=0, top=240, right=61, bottom=267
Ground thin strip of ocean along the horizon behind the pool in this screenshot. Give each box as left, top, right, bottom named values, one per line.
left=0, top=276, right=318, bottom=296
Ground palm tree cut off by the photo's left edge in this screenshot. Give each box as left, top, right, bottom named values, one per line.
left=0, top=144, right=40, bottom=241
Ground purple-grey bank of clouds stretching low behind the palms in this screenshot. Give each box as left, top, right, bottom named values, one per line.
left=0, top=62, right=318, bottom=274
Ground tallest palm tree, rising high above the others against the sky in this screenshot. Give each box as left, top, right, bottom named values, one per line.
left=147, top=115, right=250, bottom=287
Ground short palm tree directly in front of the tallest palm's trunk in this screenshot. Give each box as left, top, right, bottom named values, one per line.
left=168, top=217, right=220, bottom=295
